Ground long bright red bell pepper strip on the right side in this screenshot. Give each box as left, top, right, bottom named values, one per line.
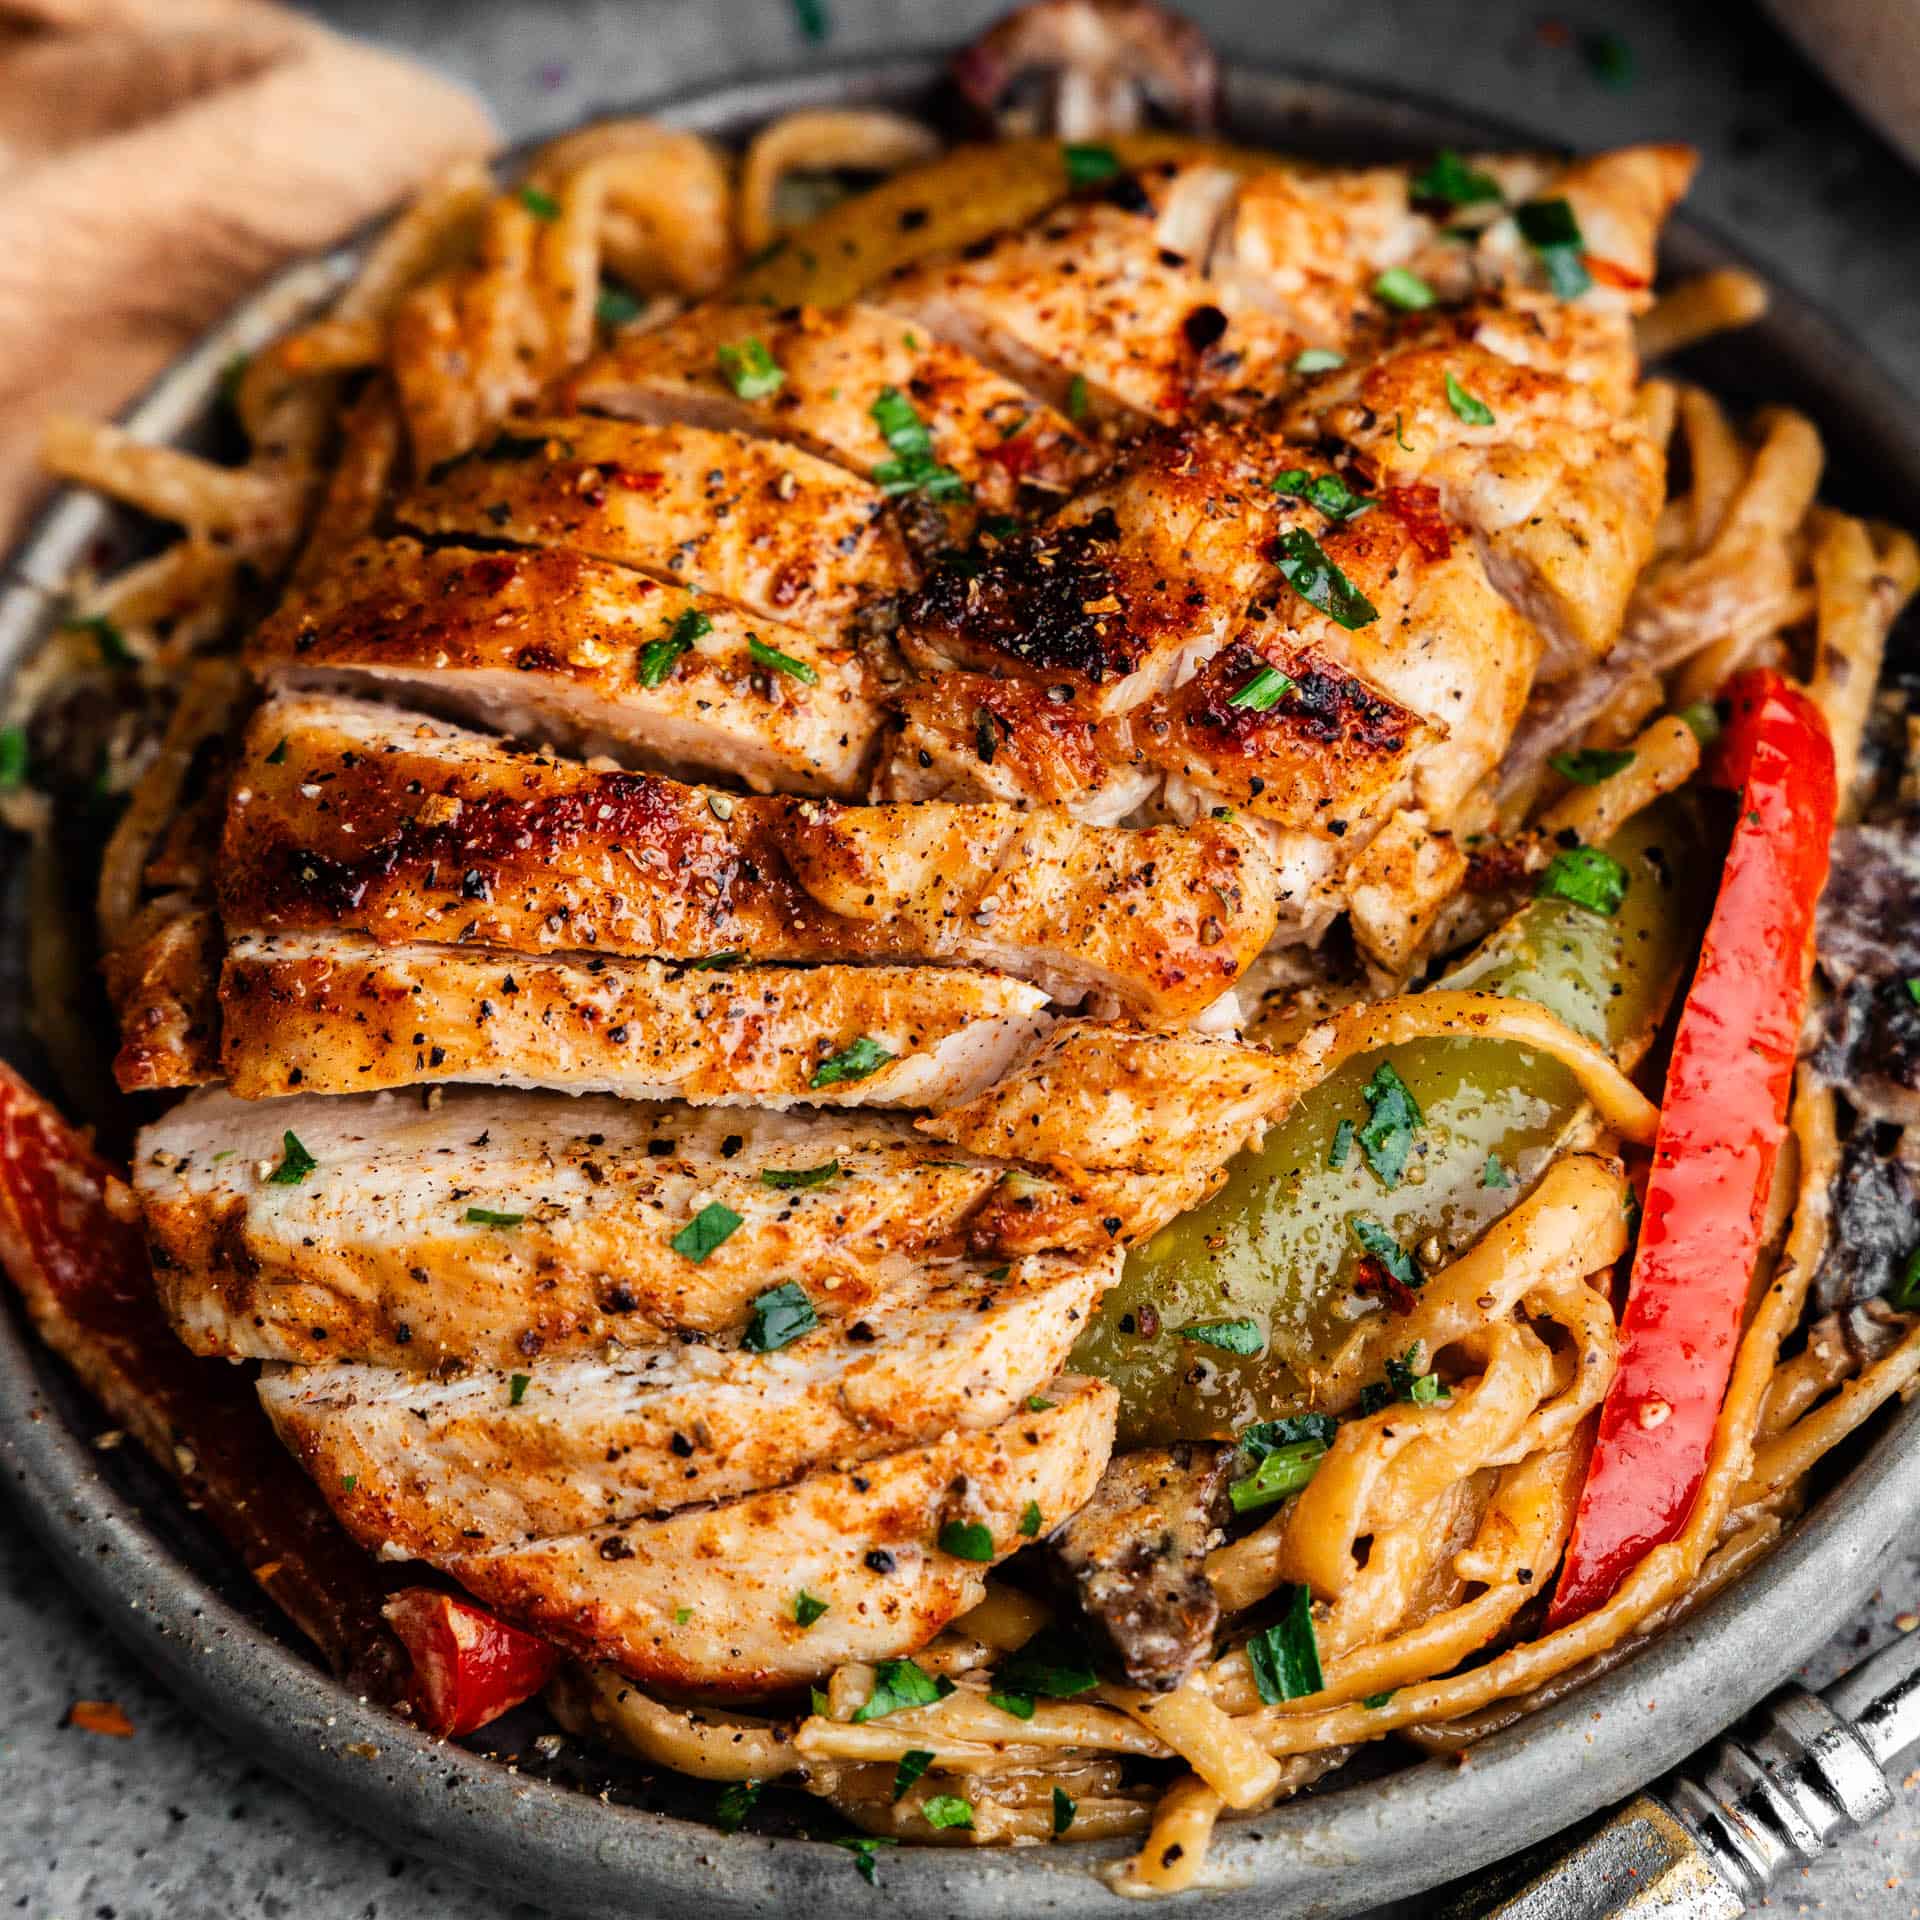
left=1548, top=672, right=1837, bottom=1630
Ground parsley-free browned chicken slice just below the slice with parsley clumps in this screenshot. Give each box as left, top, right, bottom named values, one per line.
left=394, top=415, right=908, bottom=628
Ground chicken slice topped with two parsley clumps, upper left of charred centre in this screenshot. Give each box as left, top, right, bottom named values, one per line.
left=566, top=301, right=1094, bottom=513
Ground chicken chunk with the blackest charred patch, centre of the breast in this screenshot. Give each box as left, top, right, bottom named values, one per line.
left=900, top=422, right=1304, bottom=714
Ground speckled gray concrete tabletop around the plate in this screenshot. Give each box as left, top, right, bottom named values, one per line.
left=0, top=0, right=1920, bottom=1920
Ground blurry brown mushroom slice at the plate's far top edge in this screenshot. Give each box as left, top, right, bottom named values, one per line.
left=950, top=0, right=1219, bottom=140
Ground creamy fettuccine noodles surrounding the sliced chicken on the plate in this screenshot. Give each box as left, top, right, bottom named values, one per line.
left=10, top=93, right=1920, bottom=1893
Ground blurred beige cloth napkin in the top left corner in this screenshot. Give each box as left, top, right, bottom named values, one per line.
left=0, top=0, right=495, bottom=545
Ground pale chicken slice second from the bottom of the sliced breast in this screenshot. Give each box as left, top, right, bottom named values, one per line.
left=259, top=1252, right=1119, bottom=1557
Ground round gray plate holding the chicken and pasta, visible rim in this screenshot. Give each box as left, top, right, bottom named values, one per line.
left=0, top=48, right=1920, bottom=1920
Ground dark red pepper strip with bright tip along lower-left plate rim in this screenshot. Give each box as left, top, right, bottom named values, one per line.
left=0, top=1066, right=561, bottom=1734
